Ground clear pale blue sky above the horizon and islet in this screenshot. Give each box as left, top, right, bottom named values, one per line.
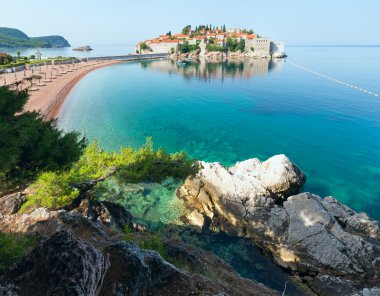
left=0, top=0, right=380, bottom=45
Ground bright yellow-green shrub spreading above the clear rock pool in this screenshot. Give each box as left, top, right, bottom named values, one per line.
left=21, top=138, right=198, bottom=211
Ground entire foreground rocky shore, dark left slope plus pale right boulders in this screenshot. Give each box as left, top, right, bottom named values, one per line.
left=0, top=155, right=380, bottom=296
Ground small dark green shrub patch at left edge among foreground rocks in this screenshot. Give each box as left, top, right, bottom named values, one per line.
left=0, top=233, right=37, bottom=273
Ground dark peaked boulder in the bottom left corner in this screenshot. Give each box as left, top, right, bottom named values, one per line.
left=0, top=231, right=109, bottom=296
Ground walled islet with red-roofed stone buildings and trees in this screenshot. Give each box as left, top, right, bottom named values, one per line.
left=136, top=25, right=286, bottom=58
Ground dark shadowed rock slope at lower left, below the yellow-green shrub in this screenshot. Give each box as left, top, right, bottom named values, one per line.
left=0, top=194, right=278, bottom=296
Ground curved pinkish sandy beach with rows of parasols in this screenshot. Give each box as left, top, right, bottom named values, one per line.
left=0, top=61, right=120, bottom=119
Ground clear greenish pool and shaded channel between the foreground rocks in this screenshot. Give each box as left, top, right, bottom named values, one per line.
left=94, top=178, right=303, bottom=296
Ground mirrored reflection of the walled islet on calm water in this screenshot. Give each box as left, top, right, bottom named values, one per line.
left=141, top=59, right=284, bottom=80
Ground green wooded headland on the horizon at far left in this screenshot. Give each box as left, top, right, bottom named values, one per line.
left=0, top=27, right=70, bottom=48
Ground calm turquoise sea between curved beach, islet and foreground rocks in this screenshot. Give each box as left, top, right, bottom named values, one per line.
left=59, top=47, right=380, bottom=219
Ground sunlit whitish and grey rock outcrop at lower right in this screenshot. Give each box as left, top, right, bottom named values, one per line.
left=177, top=155, right=380, bottom=295
